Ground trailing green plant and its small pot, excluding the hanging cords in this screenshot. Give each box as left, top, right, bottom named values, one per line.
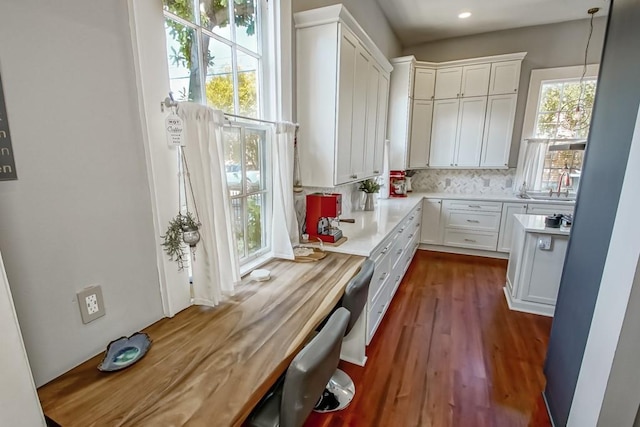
left=160, top=211, right=200, bottom=270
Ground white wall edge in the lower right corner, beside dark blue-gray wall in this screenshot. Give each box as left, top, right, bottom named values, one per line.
left=567, top=105, right=640, bottom=427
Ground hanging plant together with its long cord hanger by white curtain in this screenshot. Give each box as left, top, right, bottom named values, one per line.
left=160, top=147, right=201, bottom=271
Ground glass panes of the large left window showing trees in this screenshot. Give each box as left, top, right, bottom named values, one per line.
left=163, top=0, right=267, bottom=262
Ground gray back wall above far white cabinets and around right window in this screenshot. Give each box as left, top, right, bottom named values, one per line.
left=403, top=17, right=606, bottom=167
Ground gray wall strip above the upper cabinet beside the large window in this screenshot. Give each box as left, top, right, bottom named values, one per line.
left=291, top=0, right=401, bottom=58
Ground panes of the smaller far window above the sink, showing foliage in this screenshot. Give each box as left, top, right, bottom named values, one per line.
left=535, top=79, right=597, bottom=191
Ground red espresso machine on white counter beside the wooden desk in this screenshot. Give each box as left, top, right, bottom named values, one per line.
left=306, top=193, right=342, bottom=243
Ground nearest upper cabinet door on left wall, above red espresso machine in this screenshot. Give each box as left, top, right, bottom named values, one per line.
left=336, top=28, right=366, bottom=185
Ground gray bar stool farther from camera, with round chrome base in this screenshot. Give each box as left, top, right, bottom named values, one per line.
left=314, top=258, right=375, bottom=412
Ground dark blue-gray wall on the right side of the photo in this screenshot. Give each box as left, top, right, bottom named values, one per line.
left=545, top=0, right=640, bottom=426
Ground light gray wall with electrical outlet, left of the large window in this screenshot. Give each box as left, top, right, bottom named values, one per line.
left=0, top=0, right=163, bottom=385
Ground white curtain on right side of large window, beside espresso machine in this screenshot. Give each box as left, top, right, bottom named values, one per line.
left=271, top=122, right=299, bottom=259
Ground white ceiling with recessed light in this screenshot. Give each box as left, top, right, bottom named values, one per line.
left=378, top=0, right=609, bottom=46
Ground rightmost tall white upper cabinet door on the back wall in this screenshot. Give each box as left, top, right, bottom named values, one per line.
left=480, top=94, right=518, bottom=168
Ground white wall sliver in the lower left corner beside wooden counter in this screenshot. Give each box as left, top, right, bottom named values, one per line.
left=0, top=254, right=44, bottom=427
